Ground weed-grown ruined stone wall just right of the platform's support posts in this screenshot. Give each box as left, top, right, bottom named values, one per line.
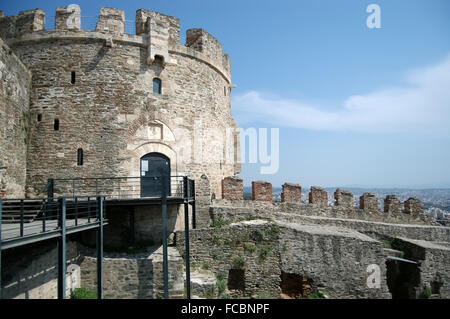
left=175, top=221, right=281, bottom=297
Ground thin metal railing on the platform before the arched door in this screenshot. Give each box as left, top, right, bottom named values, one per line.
left=46, top=176, right=195, bottom=200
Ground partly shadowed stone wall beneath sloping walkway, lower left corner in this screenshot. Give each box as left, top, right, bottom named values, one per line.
left=2, top=240, right=80, bottom=299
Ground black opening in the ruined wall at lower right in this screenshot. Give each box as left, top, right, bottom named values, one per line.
left=386, top=260, right=420, bottom=299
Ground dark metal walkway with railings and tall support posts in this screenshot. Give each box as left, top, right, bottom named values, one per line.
left=0, top=176, right=195, bottom=299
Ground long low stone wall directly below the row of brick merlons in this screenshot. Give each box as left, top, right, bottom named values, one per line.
left=210, top=200, right=450, bottom=242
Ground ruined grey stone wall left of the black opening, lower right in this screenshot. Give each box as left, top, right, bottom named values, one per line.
left=278, top=223, right=390, bottom=299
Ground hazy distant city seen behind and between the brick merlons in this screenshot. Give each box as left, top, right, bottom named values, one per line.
left=244, top=186, right=450, bottom=225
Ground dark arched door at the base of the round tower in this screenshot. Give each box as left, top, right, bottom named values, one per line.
left=141, top=152, right=170, bottom=197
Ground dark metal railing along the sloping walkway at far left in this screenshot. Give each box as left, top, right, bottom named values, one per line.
left=0, top=196, right=105, bottom=249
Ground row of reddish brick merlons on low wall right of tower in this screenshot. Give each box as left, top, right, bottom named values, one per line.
left=218, top=177, right=430, bottom=224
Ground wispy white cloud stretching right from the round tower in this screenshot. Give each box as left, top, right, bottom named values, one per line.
left=232, top=55, right=450, bottom=137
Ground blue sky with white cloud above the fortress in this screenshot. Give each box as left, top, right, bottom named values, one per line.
left=0, top=0, right=450, bottom=187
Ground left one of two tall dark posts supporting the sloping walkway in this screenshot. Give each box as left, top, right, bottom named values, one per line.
left=58, top=197, right=66, bottom=299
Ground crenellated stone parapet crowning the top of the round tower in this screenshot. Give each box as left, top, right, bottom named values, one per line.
left=0, top=5, right=231, bottom=78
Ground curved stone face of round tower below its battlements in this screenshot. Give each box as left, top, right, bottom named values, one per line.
left=7, top=32, right=234, bottom=196
